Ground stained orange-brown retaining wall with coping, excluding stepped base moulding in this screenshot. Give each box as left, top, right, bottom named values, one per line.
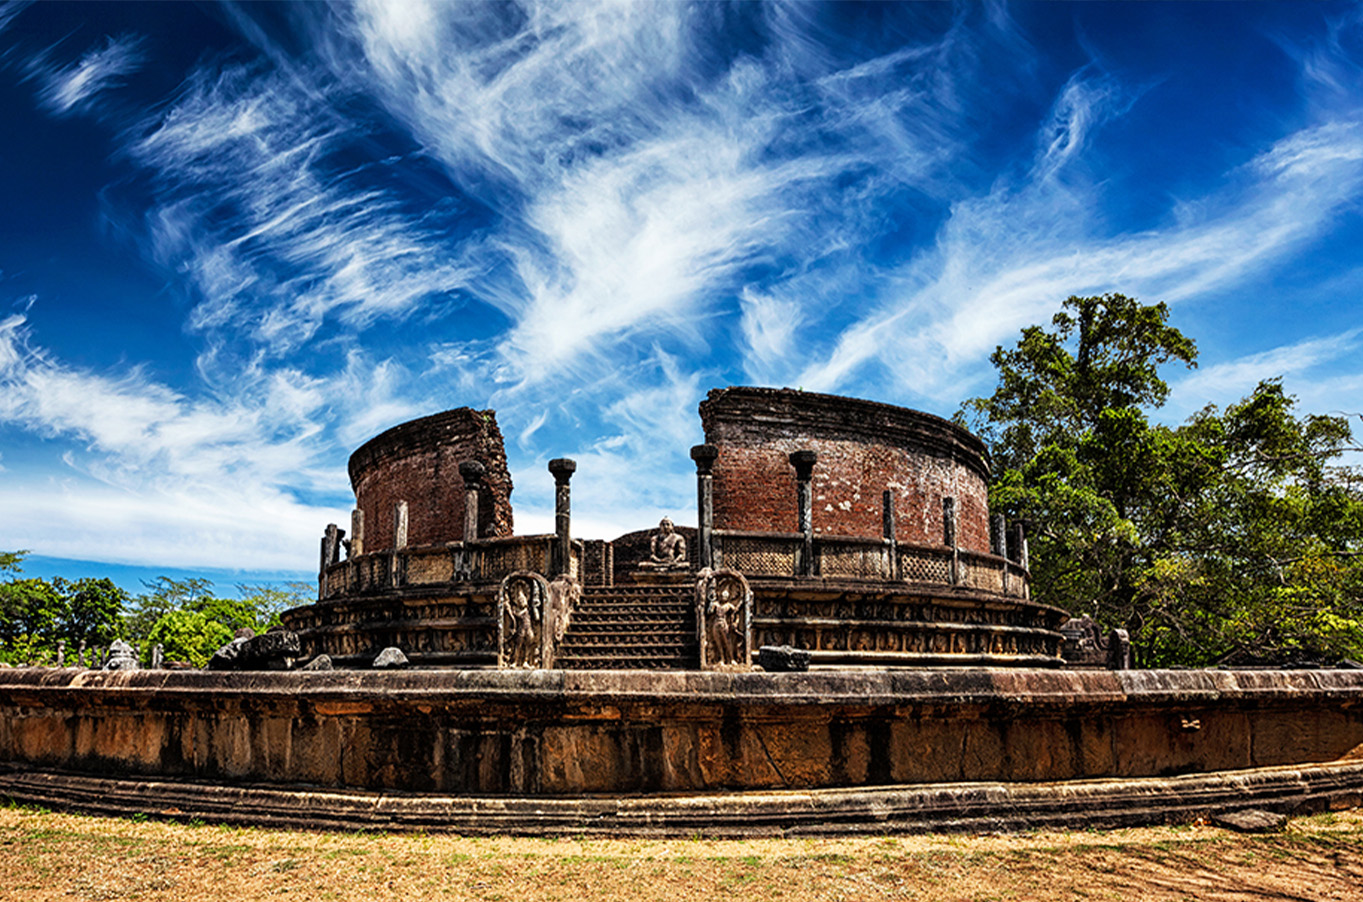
left=0, top=669, right=1363, bottom=797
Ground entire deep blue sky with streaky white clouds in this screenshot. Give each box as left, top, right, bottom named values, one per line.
left=0, top=0, right=1363, bottom=594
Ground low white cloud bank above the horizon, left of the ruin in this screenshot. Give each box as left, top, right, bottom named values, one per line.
left=0, top=316, right=345, bottom=571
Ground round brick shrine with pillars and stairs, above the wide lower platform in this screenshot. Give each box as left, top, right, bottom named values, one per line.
left=284, top=388, right=1066, bottom=670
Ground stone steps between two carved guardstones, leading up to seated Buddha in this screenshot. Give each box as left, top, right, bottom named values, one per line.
left=555, top=585, right=701, bottom=670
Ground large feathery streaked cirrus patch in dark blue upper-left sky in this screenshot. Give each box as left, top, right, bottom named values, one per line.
left=128, top=65, right=477, bottom=354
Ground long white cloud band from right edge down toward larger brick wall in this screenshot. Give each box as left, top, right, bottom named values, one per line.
left=801, top=104, right=1363, bottom=398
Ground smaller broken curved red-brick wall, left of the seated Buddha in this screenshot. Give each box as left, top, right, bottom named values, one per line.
left=350, top=407, right=511, bottom=553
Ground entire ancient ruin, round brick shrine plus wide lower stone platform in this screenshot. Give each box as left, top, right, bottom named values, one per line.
left=0, top=388, right=1363, bottom=835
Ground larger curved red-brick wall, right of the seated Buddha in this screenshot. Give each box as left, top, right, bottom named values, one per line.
left=701, top=387, right=990, bottom=553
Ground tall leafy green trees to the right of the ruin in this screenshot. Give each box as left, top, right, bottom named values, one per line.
left=960, top=294, right=1363, bottom=665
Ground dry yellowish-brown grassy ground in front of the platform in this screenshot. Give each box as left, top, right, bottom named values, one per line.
left=0, top=807, right=1363, bottom=902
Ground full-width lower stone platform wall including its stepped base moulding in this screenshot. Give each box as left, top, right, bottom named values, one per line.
left=0, top=669, right=1363, bottom=835
